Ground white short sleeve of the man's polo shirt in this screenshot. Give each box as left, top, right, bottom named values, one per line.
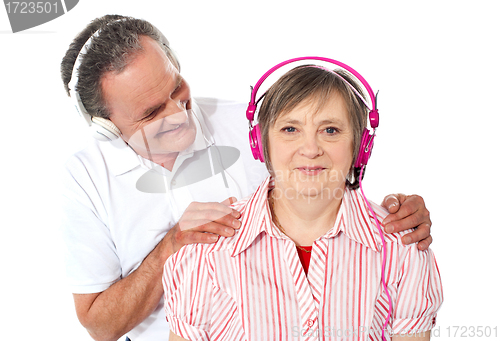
left=61, top=158, right=121, bottom=294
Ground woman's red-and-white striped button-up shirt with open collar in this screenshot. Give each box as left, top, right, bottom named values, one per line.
left=163, top=179, right=443, bottom=341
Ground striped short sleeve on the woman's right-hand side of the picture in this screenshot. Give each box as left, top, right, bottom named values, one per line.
left=392, top=244, right=443, bottom=334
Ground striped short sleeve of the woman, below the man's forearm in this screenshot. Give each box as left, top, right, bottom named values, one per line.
left=163, top=244, right=214, bottom=340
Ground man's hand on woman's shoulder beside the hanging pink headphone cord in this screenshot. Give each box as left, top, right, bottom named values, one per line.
left=382, top=194, right=432, bottom=250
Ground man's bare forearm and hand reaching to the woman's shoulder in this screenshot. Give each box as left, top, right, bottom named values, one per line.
left=73, top=198, right=241, bottom=341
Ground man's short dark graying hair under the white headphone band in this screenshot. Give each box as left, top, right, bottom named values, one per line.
left=61, top=15, right=180, bottom=118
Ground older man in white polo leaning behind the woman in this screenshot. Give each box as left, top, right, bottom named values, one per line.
left=61, top=16, right=432, bottom=341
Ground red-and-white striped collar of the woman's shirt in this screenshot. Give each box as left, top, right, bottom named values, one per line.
left=232, top=177, right=382, bottom=256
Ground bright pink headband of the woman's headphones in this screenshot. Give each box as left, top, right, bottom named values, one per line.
left=246, top=56, right=379, bottom=129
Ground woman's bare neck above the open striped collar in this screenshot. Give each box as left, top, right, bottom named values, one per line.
left=269, top=189, right=342, bottom=246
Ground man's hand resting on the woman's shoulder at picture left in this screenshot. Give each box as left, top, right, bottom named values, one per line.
left=164, top=197, right=241, bottom=253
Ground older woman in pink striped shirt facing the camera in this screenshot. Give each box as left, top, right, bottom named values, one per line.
left=163, top=62, right=442, bottom=340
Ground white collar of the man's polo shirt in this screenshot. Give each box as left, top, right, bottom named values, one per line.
left=96, top=99, right=214, bottom=176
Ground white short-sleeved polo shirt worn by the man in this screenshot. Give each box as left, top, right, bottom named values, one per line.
left=62, top=98, right=268, bottom=341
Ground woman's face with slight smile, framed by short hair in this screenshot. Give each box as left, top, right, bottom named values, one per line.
left=269, top=93, right=353, bottom=199
